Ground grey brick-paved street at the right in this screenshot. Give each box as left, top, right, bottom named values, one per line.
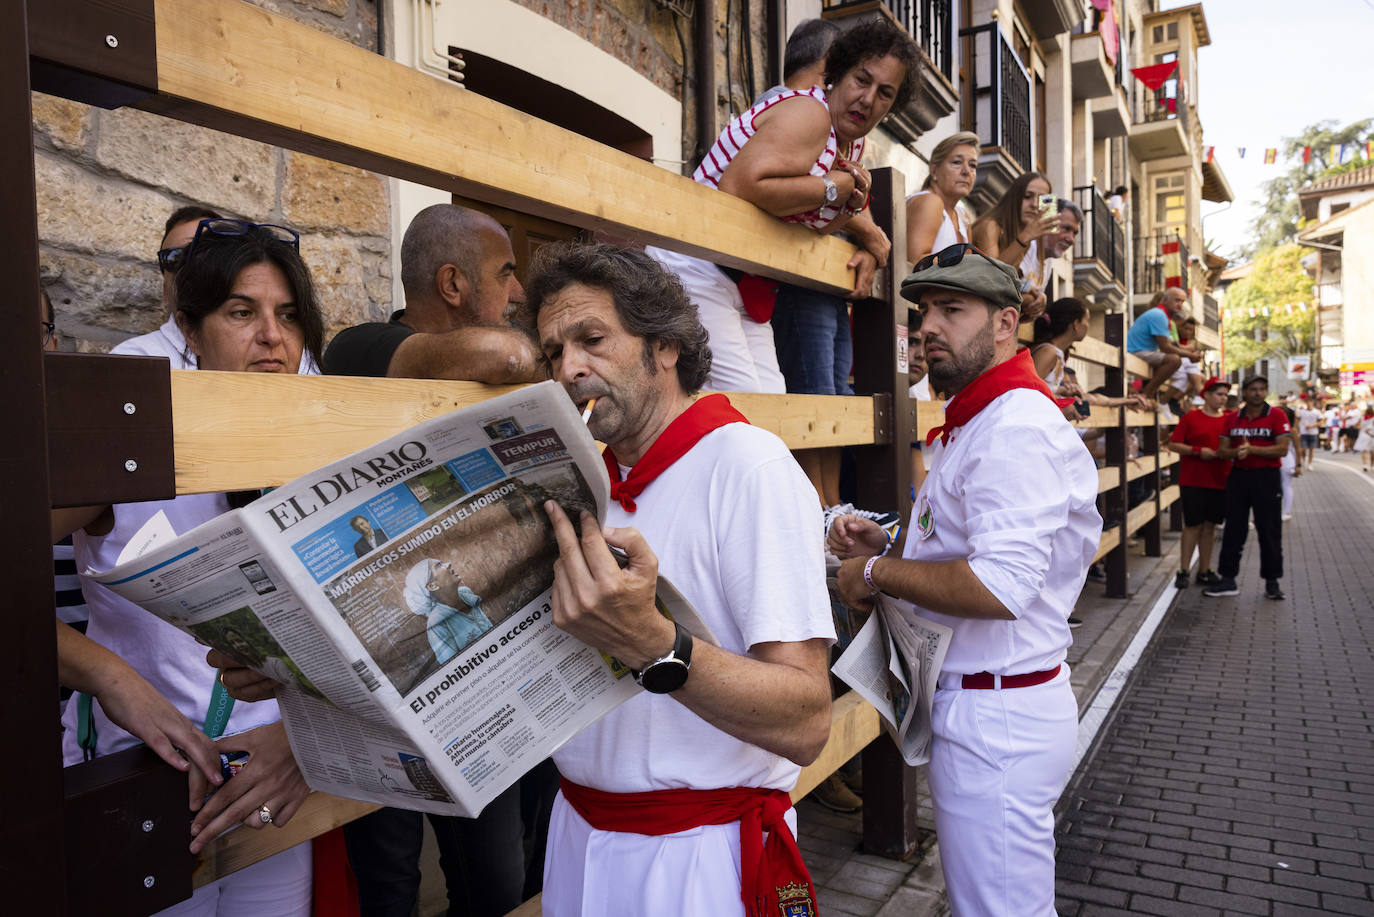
left=1058, top=455, right=1374, bottom=917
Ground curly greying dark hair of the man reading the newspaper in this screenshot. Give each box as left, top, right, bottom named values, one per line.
left=525, top=242, right=710, bottom=395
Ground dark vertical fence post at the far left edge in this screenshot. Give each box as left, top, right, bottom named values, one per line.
left=0, top=3, right=66, bottom=914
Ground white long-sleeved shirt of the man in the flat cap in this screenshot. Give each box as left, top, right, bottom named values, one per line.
left=903, top=389, right=1102, bottom=675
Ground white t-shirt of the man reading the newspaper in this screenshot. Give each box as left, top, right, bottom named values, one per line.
left=554, top=423, right=829, bottom=793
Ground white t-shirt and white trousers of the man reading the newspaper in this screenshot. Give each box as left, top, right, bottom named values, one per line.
left=543, top=401, right=835, bottom=917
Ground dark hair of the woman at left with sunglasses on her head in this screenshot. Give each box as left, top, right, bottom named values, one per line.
left=176, top=222, right=324, bottom=363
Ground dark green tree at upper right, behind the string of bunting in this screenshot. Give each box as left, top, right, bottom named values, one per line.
left=1242, top=118, right=1374, bottom=257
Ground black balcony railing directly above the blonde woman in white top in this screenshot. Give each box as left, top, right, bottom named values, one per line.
left=959, top=22, right=1032, bottom=169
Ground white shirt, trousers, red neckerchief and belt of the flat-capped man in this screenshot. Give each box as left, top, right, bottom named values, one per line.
left=903, top=351, right=1102, bottom=917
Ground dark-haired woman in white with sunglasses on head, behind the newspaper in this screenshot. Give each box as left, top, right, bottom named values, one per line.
left=55, top=220, right=323, bottom=917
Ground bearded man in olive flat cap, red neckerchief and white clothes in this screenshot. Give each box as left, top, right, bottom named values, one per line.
left=830, top=245, right=1102, bottom=916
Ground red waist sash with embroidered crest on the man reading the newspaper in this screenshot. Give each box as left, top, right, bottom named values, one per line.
left=561, top=777, right=819, bottom=917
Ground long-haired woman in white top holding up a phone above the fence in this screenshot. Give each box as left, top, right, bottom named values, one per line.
left=973, top=170, right=1059, bottom=322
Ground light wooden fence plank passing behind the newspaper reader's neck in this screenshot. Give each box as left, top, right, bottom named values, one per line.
left=172, top=370, right=872, bottom=494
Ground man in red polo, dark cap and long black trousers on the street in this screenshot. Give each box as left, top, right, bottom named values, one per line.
left=1202, top=375, right=1293, bottom=599
